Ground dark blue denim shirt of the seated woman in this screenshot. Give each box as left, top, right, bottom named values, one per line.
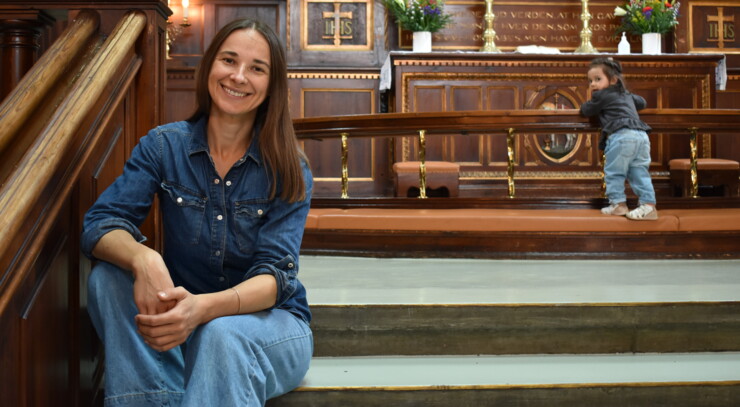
left=81, top=117, right=313, bottom=322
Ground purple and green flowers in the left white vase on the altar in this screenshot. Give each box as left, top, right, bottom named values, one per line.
left=383, top=0, right=452, bottom=32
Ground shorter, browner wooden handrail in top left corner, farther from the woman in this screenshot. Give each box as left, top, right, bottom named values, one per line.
left=0, top=10, right=100, bottom=153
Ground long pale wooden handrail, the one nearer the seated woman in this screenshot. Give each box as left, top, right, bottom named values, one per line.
left=0, top=11, right=146, bottom=262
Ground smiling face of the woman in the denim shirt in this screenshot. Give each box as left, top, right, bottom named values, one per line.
left=208, top=29, right=270, bottom=116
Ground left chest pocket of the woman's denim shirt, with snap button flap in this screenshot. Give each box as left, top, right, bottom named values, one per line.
left=161, top=181, right=208, bottom=244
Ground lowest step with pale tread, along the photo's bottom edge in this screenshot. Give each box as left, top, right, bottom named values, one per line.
left=267, top=352, right=740, bottom=407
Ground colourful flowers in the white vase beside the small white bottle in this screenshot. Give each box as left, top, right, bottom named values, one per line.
left=614, top=0, right=681, bottom=35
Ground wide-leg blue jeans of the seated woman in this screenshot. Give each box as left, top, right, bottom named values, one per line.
left=88, top=262, right=313, bottom=407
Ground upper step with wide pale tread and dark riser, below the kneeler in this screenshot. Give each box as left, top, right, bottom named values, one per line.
left=300, top=256, right=740, bottom=356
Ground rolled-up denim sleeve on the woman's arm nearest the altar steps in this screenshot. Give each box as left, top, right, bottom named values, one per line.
left=243, top=164, right=313, bottom=308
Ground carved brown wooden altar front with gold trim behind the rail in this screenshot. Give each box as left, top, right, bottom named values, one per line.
left=391, top=53, right=721, bottom=193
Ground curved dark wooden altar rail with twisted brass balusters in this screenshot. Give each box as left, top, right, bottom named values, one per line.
left=293, top=109, right=740, bottom=198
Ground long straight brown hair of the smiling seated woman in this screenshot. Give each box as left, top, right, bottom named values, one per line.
left=187, top=18, right=308, bottom=202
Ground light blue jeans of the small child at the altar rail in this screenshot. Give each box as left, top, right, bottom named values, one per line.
left=604, top=129, right=655, bottom=204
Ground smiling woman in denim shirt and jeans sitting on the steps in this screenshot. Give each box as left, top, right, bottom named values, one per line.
left=82, top=20, right=313, bottom=406
